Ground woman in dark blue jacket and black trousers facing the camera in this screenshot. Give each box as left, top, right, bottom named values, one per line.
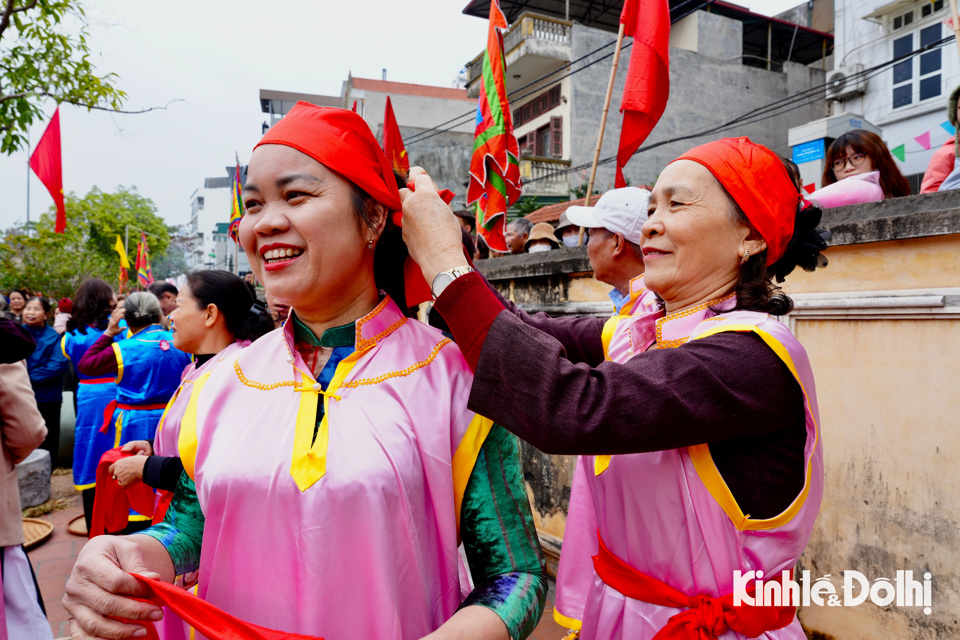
left=23, top=297, right=70, bottom=467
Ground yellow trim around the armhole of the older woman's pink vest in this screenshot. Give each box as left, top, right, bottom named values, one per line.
left=687, top=324, right=820, bottom=531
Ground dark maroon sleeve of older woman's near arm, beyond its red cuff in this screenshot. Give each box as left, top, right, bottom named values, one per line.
left=469, top=313, right=803, bottom=455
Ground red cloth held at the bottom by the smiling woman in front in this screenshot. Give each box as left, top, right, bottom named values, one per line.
left=130, top=574, right=323, bottom=640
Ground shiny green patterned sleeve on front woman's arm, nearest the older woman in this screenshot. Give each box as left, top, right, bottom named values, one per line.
left=460, top=424, right=547, bottom=640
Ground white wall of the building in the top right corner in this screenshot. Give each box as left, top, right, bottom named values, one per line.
left=834, top=0, right=960, bottom=175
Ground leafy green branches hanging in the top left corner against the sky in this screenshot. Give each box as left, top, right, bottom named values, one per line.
left=0, top=0, right=126, bottom=154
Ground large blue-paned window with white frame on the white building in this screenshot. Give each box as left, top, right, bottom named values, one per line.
left=893, top=22, right=943, bottom=109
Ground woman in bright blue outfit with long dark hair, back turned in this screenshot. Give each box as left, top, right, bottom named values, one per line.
left=61, top=278, right=117, bottom=531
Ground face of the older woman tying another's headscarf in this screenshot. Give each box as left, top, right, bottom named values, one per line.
left=640, top=160, right=766, bottom=313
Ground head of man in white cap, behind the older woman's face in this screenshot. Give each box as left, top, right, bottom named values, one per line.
left=566, top=187, right=650, bottom=313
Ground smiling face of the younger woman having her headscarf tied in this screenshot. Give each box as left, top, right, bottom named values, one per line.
left=240, top=144, right=378, bottom=317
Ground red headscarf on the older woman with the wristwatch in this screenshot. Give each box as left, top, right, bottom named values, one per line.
left=674, top=138, right=800, bottom=266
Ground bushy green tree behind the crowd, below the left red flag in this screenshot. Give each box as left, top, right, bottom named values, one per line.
left=0, top=187, right=170, bottom=297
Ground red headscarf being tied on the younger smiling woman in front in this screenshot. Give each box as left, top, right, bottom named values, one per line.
left=254, top=101, right=400, bottom=211
